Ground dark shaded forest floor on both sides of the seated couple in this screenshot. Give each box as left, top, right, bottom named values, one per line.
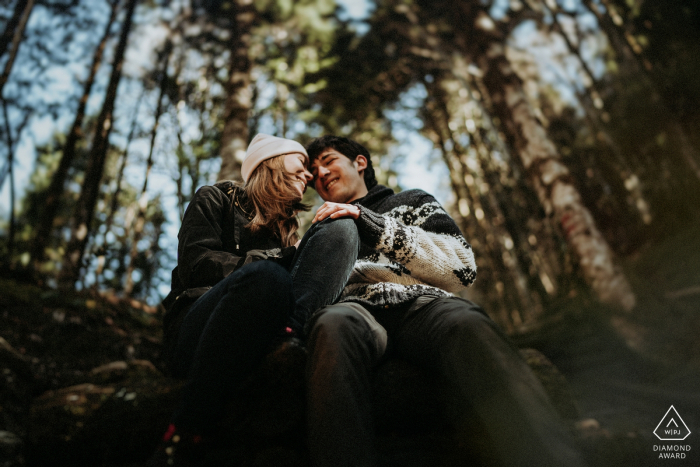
left=0, top=226, right=700, bottom=467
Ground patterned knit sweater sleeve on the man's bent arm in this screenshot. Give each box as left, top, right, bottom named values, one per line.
left=356, top=190, right=476, bottom=293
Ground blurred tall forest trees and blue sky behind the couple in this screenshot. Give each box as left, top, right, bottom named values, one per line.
left=0, top=0, right=700, bottom=332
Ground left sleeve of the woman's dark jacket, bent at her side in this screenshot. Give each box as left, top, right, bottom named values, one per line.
left=177, top=186, right=241, bottom=289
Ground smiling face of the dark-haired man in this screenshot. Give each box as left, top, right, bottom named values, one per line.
left=311, top=149, right=367, bottom=203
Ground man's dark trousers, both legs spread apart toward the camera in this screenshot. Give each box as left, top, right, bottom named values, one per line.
left=307, top=297, right=584, bottom=467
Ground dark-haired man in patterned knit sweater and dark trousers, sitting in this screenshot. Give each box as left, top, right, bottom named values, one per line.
left=306, top=136, right=583, bottom=467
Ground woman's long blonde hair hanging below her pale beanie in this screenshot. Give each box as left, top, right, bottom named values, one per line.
left=243, top=155, right=311, bottom=247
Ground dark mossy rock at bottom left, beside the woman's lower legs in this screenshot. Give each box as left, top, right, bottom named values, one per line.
left=26, top=362, right=181, bottom=467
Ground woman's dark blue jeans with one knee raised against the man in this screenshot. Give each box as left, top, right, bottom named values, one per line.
left=172, top=219, right=359, bottom=434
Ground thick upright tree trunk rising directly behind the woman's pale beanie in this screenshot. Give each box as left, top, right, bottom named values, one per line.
left=219, top=0, right=256, bottom=180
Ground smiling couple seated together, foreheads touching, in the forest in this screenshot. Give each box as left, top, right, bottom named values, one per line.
left=155, top=134, right=583, bottom=467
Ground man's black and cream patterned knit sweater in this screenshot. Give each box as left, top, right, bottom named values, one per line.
left=339, top=185, right=476, bottom=308
